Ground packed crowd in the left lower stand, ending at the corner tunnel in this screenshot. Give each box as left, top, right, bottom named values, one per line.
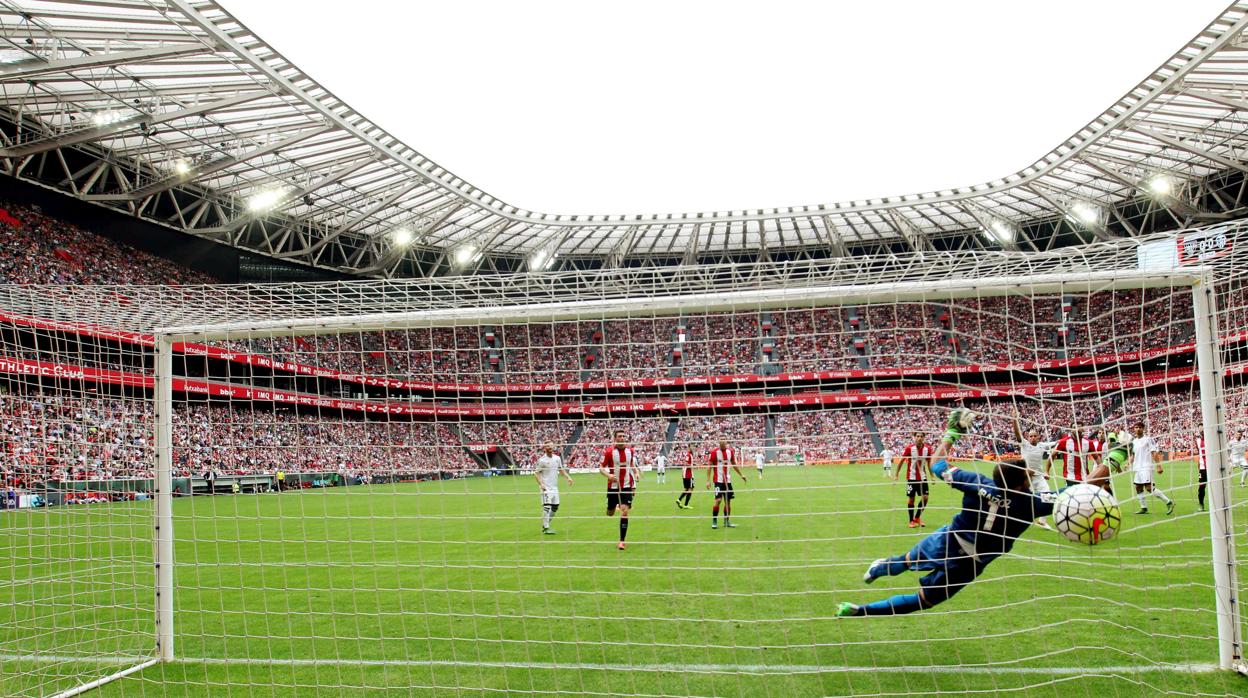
left=0, top=392, right=478, bottom=484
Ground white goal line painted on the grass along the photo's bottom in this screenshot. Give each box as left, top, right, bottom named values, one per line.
left=0, top=654, right=1218, bottom=677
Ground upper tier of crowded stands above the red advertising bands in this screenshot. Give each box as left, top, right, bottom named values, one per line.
left=0, top=205, right=1218, bottom=394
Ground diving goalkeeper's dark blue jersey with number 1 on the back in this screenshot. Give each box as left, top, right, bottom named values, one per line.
left=932, top=461, right=1053, bottom=563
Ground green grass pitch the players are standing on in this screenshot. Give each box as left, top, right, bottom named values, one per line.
left=0, top=463, right=1248, bottom=698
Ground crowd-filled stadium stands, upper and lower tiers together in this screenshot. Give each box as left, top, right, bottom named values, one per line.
left=0, top=204, right=1248, bottom=486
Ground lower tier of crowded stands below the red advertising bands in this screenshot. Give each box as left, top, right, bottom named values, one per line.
left=0, top=383, right=1248, bottom=488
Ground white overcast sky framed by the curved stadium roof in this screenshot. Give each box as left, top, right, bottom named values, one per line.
left=223, top=0, right=1227, bottom=214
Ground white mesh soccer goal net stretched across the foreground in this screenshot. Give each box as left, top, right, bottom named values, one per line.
left=0, top=226, right=1248, bottom=697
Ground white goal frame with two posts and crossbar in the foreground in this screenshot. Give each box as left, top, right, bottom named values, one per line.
left=134, top=267, right=1246, bottom=686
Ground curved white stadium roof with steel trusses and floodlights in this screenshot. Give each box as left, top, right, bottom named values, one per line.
left=0, top=0, right=1248, bottom=276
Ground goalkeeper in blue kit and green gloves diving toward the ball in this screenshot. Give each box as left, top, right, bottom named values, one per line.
left=836, top=408, right=1109, bottom=617
